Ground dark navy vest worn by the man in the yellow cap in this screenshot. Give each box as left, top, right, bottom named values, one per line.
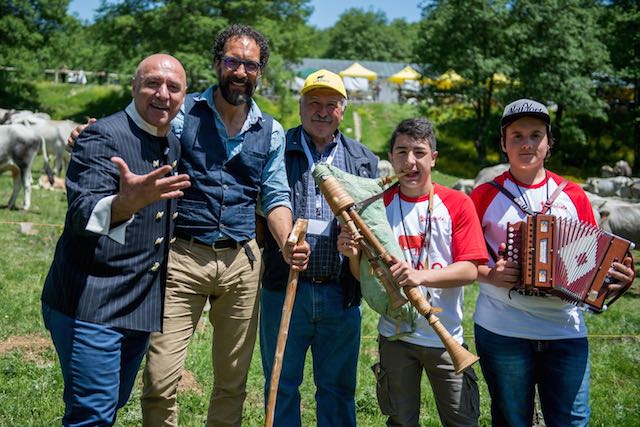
left=262, top=126, right=378, bottom=307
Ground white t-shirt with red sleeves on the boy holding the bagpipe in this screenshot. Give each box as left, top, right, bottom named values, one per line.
left=378, top=183, right=488, bottom=348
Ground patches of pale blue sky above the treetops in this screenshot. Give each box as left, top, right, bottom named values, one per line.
left=69, top=0, right=420, bottom=29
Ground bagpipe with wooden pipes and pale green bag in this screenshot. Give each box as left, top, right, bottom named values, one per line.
left=313, top=163, right=479, bottom=373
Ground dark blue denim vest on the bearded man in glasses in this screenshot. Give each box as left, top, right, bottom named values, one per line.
left=176, top=94, right=273, bottom=244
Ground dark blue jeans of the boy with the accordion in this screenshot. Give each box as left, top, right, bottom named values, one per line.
left=475, top=325, right=591, bottom=427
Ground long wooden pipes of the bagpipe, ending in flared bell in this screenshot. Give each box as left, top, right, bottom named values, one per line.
left=319, top=174, right=479, bottom=374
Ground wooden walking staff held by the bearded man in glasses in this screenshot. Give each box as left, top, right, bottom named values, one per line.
left=264, top=219, right=309, bottom=427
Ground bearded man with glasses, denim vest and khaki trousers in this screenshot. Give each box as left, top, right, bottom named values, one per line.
left=136, top=25, right=308, bottom=427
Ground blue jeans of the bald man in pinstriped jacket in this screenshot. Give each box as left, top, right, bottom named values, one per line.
left=42, top=304, right=149, bottom=426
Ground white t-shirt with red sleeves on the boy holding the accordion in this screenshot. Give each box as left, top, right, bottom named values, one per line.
left=470, top=171, right=596, bottom=340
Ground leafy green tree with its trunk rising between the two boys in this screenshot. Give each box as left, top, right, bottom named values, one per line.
left=415, top=0, right=510, bottom=164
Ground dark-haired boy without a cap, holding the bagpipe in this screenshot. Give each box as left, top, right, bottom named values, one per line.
left=338, top=118, right=488, bottom=426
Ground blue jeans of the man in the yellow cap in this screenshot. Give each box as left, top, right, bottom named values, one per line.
left=260, top=280, right=362, bottom=427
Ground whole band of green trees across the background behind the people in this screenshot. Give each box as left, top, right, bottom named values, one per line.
left=0, top=0, right=640, bottom=173
